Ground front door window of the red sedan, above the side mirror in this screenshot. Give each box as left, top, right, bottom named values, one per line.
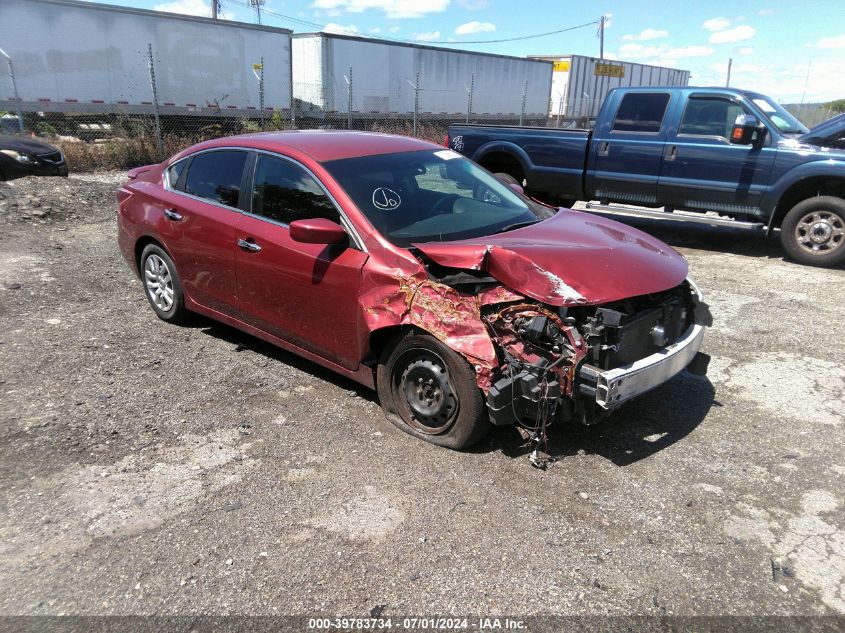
left=252, top=154, right=340, bottom=224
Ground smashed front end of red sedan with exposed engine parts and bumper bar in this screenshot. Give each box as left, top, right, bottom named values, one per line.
left=409, top=244, right=710, bottom=441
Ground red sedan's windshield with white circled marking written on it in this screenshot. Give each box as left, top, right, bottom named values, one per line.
left=323, top=149, right=545, bottom=246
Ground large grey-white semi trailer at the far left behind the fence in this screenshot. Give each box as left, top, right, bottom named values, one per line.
left=0, top=0, right=291, bottom=117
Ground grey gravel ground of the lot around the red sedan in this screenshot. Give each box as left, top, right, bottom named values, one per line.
left=0, top=174, right=845, bottom=617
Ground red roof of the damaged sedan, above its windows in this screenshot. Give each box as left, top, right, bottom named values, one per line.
left=184, top=130, right=442, bottom=163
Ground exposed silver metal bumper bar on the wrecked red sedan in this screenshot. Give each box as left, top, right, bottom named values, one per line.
left=579, top=323, right=704, bottom=409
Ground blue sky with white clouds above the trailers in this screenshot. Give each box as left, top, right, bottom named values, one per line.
left=82, top=0, right=845, bottom=103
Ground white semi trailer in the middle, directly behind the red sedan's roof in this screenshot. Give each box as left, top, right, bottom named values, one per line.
left=293, top=33, right=552, bottom=120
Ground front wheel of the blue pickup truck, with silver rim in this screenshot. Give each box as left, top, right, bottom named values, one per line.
left=780, top=196, right=845, bottom=266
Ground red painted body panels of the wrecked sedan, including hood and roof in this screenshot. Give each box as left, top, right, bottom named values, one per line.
left=118, top=131, right=687, bottom=390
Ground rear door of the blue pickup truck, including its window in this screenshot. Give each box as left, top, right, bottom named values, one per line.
left=587, top=91, right=672, bottom=205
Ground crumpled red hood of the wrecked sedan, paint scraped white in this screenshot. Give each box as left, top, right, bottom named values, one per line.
left=413, top=210, right=688, bottom=306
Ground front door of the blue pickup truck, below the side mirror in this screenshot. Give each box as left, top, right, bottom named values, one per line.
left=658, top=94, right=777, bottom=215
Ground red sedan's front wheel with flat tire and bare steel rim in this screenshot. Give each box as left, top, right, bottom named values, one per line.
left=376, top=334, right=490, bottom=449
